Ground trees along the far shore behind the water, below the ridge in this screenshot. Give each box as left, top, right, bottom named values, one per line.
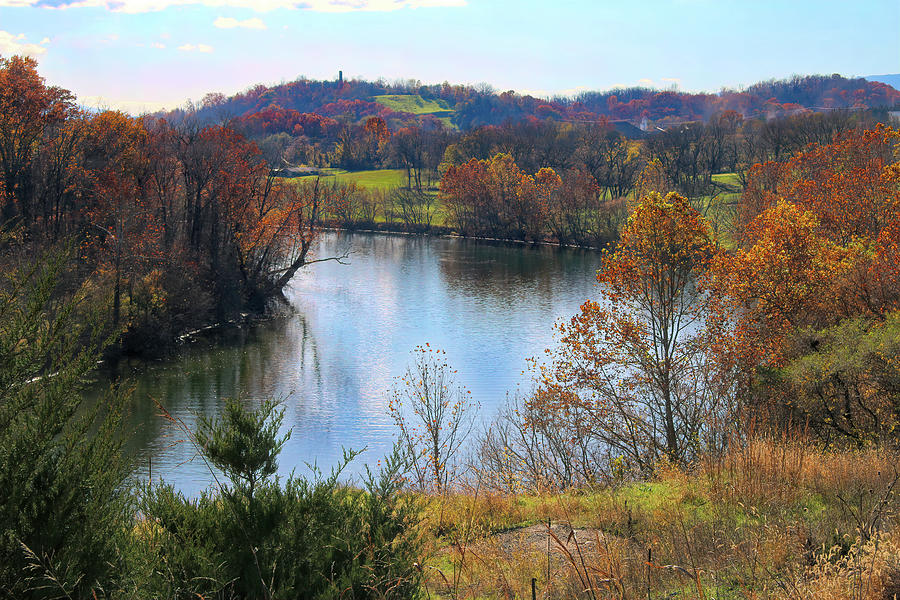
left=312, top=104, right=881, bottom=247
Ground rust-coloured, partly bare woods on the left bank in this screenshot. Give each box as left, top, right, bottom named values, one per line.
left=0, top=57, right=352, bottom=351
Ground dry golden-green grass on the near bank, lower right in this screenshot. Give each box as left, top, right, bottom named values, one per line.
left=426, top=438, right=900, bottom=600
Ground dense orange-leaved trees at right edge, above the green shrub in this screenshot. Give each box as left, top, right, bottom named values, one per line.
left=716, top=127, right=900, bottom=362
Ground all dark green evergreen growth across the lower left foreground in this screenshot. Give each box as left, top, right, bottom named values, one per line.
left=0, top=255, right=420, bottom=599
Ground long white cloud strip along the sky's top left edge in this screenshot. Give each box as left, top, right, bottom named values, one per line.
left=0, top=0, right=467, bottom=12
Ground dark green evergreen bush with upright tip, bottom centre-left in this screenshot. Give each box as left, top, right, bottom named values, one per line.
left=134, top=401, right=420, bottom=598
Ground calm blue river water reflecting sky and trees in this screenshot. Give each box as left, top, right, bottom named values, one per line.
left=100, top=233, right=600, bottom=495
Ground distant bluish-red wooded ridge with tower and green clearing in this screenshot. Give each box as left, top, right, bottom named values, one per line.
left=171, top=74, right=900, bottom=137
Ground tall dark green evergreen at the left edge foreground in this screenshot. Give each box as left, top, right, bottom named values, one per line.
left=0, top=247, right=131, bottom=598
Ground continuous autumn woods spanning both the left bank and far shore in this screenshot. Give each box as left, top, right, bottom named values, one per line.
left=0, top=52, right=881, bottom=351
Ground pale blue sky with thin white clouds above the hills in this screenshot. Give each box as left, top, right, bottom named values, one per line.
left=0, top=0, right=900, bottom=113
